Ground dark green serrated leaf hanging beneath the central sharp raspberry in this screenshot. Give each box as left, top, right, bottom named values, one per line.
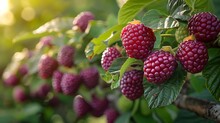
left=144, top=65, right=186, bottom=108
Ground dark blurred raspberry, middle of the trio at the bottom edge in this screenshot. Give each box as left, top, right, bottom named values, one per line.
left=90, top=95, right=109, bottom=117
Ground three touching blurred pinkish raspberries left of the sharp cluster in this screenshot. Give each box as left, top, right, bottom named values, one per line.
left=52, top=67, right=99, bottom=95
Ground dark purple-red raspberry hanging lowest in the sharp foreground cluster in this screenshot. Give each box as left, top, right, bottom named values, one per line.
left=120, top=70, right=144, bottom=100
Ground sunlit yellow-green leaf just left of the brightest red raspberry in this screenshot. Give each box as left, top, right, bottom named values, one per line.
left=85, top=24, right=125, bottom=59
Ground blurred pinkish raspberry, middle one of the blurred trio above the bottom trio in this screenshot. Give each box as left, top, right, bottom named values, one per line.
left=60, top=73, right=81, bottom=95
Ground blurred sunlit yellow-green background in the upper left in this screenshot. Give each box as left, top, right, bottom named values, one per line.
left=0, top=0, right=119, bottom=74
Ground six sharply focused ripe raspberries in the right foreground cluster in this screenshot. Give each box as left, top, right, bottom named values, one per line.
left=101, top=12, right=220, bottom=100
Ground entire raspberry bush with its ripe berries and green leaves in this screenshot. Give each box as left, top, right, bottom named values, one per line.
left=3, top=0, right=220, bottom=123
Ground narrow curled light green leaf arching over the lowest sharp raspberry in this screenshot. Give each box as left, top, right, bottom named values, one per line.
left=119, top=58, right=143, bottom=80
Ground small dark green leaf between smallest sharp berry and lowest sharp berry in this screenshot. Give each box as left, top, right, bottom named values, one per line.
left=108, top=57, right=128, bottom=73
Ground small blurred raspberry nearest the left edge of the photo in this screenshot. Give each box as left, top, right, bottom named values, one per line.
left=4, top=74, right=20, bottom=86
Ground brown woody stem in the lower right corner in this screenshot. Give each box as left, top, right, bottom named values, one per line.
left=174, top=94, right=220, bottom=122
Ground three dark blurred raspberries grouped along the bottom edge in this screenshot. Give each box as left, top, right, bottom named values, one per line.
left=73, top=94, right=119, bottom=123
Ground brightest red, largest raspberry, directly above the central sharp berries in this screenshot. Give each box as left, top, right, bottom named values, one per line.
left=121, top=21, right=156, bottom=60
